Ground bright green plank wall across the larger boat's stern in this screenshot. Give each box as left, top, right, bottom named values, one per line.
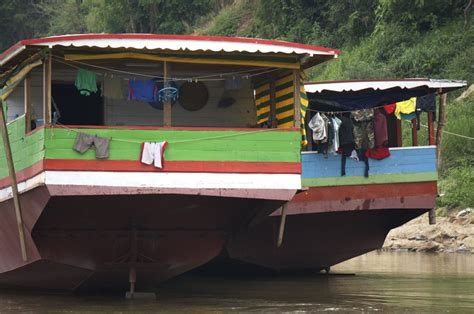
left=45, top=128, right=300, bottom=162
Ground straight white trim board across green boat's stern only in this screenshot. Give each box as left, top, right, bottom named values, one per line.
left=45, top=171, right=301, bottom=190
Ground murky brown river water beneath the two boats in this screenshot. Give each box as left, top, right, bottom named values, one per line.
left=0, top=252, right=474, bottom=313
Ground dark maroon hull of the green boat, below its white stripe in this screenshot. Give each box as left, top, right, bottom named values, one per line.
left=0, top=186, right=282, bottom=292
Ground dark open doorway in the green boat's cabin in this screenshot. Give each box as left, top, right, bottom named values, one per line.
left=52, top=82, right=104, bottom=125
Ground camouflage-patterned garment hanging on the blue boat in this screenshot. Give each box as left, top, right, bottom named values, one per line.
left=351, top=109, right=375, bottom=150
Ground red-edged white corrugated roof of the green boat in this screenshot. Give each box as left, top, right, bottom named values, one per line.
left=0, top=34, right=340, bottom=65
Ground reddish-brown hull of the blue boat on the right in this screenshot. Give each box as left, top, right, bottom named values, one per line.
left=206, top=182, right=436, bottom=272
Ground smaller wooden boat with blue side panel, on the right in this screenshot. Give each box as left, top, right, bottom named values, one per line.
left=217, top=79, right=466, bottom=271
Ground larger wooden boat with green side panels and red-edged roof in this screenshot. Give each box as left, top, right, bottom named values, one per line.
left=0, top=34, right=339, bottom=292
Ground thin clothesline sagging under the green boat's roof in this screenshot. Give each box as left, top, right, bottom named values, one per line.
left=53, top=56, right=279, bottom=83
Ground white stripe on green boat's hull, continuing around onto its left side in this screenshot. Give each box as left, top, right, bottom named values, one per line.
left=0, top=171, right=301, bottom=202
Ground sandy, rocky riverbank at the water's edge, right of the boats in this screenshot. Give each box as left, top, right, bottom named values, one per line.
left=382, top=208, right=474, bottom=254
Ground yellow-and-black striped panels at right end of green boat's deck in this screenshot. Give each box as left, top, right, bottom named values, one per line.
left=255, top=74, right=308, bottom=146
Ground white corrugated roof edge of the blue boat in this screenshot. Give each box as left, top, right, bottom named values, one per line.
left=305, top=78, right=467, bottom=93
